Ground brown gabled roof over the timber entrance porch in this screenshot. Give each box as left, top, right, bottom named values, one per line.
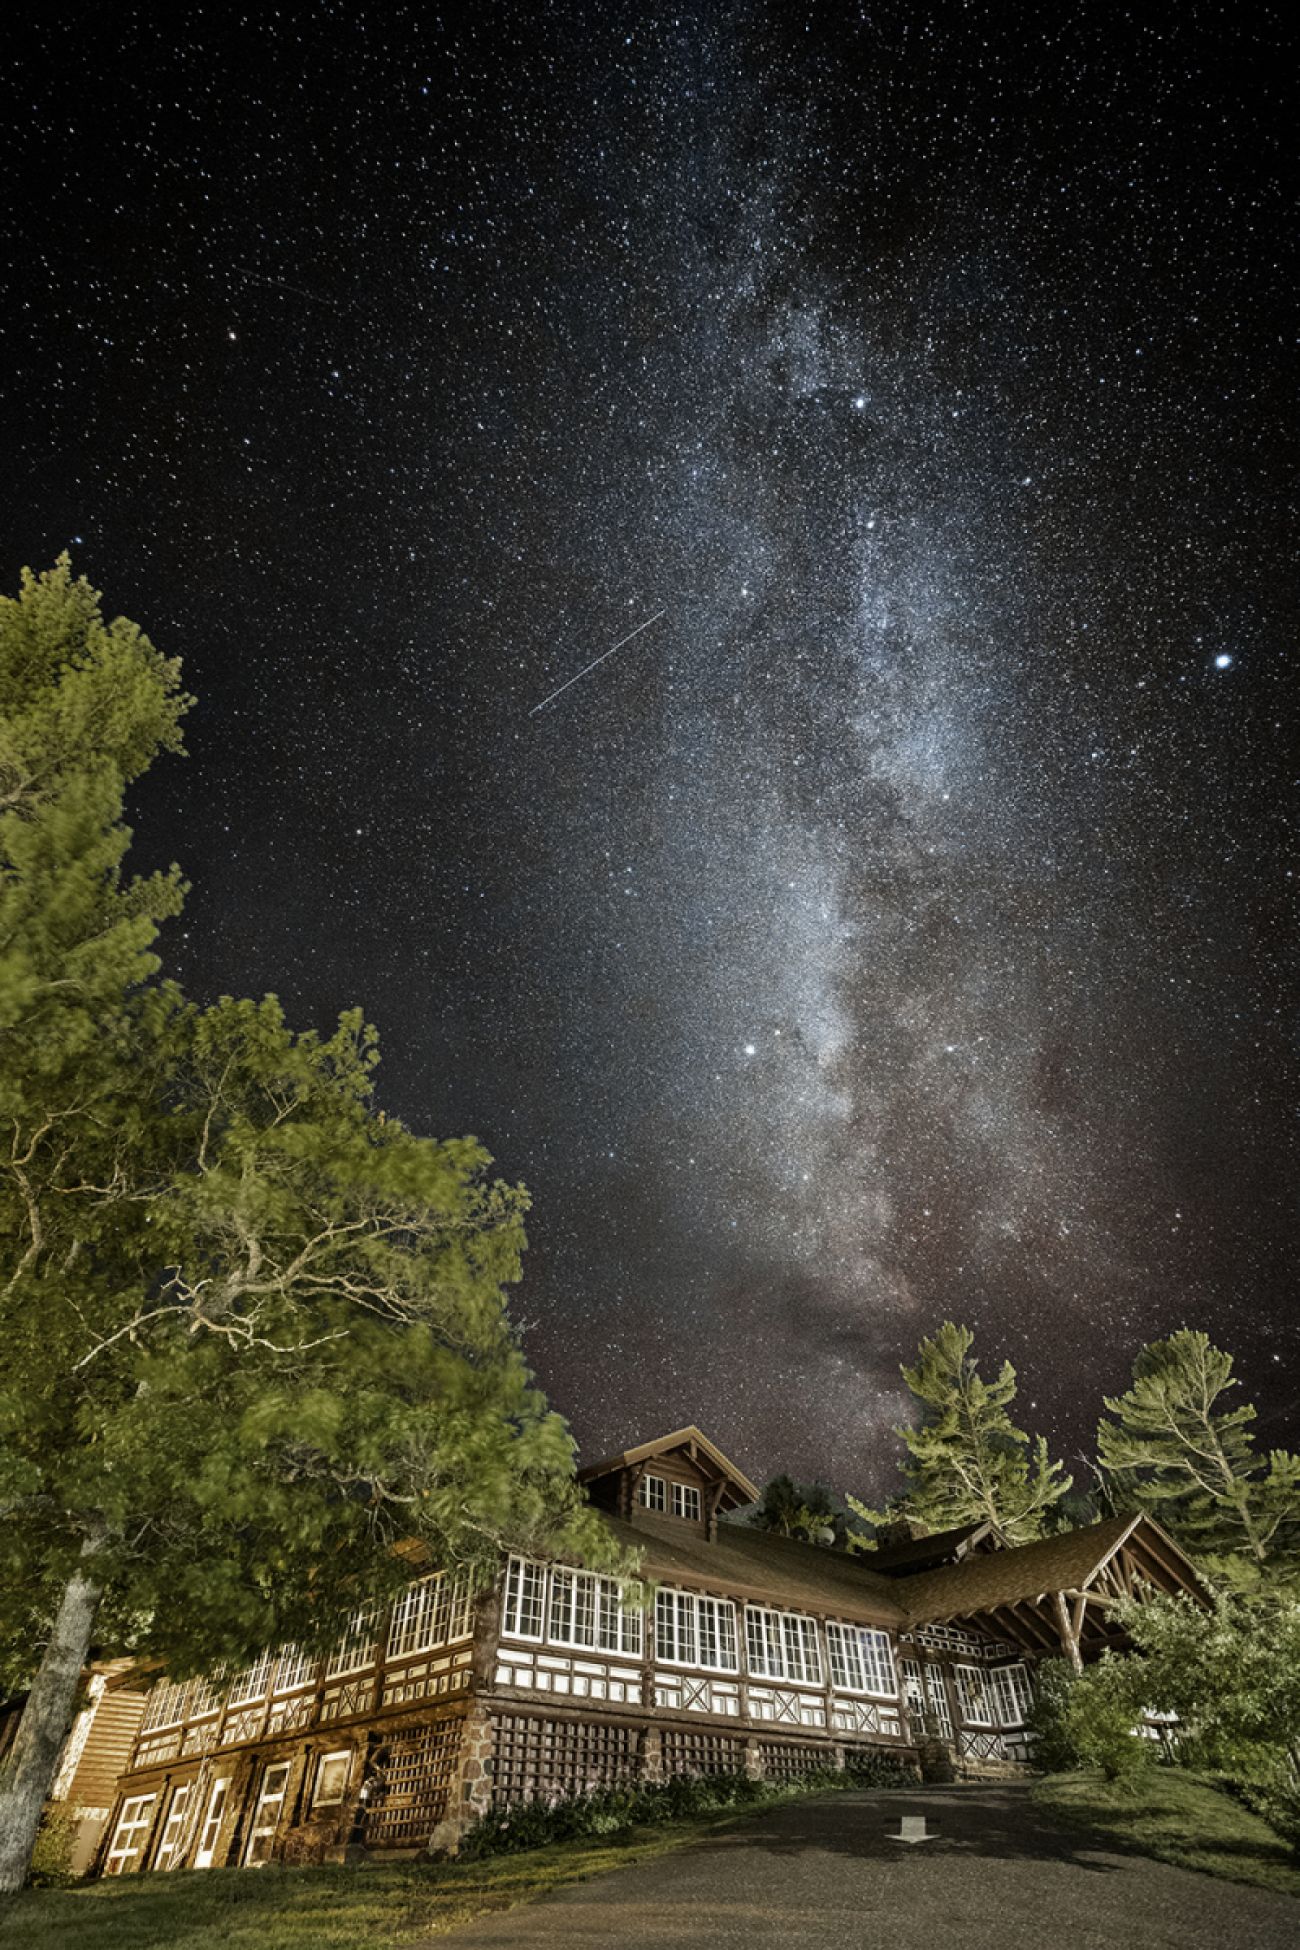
left=895, top=1517, right=1206, bottom=1624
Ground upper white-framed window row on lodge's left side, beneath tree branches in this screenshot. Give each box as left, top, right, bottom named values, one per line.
left=140, top=1572, right=474, bottom=1734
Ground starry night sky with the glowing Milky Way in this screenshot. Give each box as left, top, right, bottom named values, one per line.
left=0, top=0, right=1300, bottom=1494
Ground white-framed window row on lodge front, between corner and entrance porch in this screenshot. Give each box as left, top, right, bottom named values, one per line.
left=501, top=1558, right=899, bottom=1698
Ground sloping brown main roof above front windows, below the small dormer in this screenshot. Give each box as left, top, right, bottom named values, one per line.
left=602, top=1513, right=908, bottom=1628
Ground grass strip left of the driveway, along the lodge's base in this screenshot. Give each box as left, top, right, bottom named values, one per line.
left=0, top=1794, right=795, bottom=1950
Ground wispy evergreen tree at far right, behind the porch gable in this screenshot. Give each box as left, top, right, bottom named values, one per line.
left=1097, top=1328, right=1300, bottom=1591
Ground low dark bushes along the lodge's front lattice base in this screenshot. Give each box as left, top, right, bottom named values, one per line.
left=460, top=1753, right=912, bottom=1862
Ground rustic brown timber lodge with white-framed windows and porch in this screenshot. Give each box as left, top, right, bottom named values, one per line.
left=74, top=1427, right=1204, bottom=1876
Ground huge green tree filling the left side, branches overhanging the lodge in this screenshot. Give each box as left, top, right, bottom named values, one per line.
left=0, top=560, right=618, bottom=1892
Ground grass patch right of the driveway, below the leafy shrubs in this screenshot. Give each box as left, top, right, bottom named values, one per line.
left=1033, top=1767, right=1300, bottom=1895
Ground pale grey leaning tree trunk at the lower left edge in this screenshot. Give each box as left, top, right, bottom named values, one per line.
left=0, top=1542, right=103, bottom=1895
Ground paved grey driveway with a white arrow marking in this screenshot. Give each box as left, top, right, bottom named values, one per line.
left=437, top=1786, right=1300, bottom=1950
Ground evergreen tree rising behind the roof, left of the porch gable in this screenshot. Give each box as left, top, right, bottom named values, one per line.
left=873, top=1320, right=1072, bottom=1544
